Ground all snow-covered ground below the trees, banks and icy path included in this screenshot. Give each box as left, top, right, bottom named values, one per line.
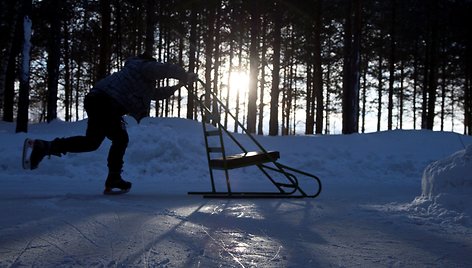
left=0, top=118, right=472, bottom=267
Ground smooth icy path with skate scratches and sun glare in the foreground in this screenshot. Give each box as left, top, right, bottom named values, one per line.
left=0, top=180, right=472, bottom=267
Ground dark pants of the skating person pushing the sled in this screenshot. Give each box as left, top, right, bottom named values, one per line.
left=51, top=91, right=129, bottom=173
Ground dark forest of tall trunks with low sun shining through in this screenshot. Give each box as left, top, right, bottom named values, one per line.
left=0, top=0, right=472, bottom=136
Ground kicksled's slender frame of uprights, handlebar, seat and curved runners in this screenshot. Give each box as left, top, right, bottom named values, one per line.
left=184, top=80, right=321, bottom=198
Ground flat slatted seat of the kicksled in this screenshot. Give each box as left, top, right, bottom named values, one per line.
left=210, top=151, right=280, bottom=170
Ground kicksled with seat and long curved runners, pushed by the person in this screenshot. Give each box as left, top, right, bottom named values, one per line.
left=188, top=80, right=321, bottom=198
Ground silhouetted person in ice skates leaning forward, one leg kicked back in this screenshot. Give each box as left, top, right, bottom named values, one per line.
left=30, top=52, right=197, bottom=194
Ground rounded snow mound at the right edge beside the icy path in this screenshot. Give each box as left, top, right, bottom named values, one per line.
left=410, top=145, right=472, bottom=223
